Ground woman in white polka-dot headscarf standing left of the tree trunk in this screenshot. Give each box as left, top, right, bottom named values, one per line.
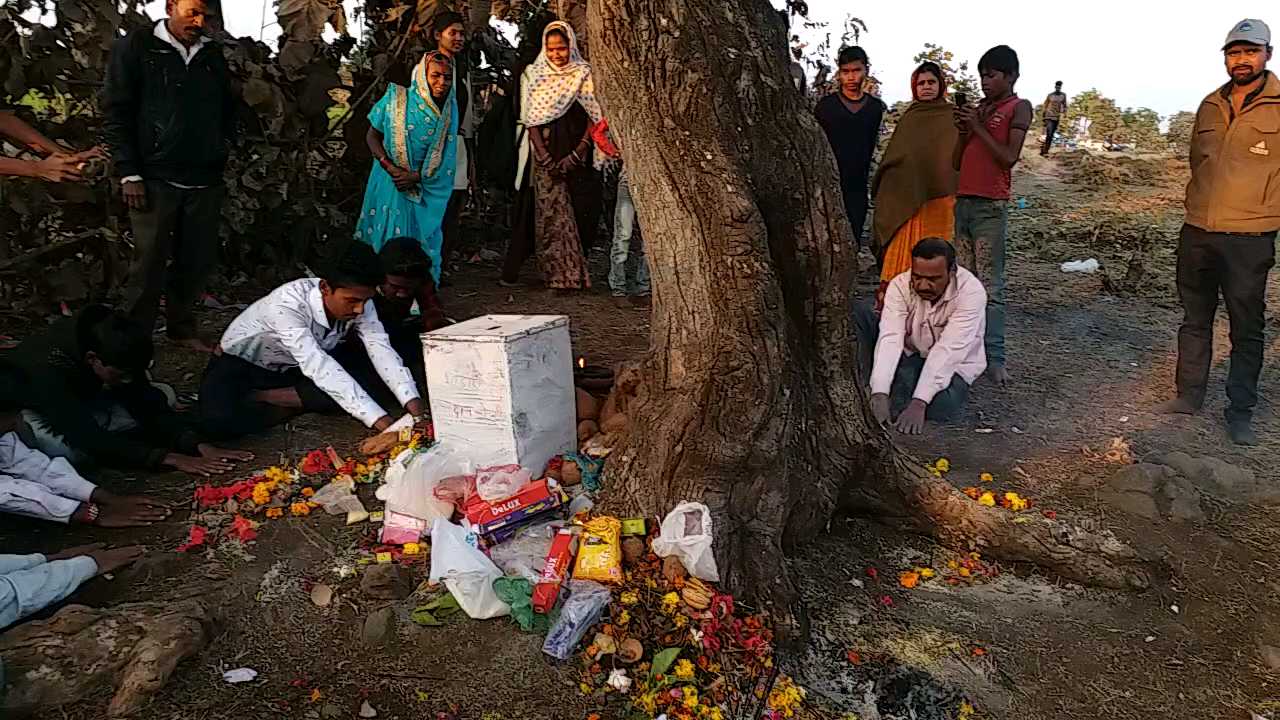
left=504, top=20, right=600, bottom=291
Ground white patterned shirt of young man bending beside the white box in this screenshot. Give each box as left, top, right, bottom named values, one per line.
left=221, top=278, right=419, bottom=427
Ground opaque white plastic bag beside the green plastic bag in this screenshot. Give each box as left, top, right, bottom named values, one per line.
left=431, top=519, right=511, bottom=620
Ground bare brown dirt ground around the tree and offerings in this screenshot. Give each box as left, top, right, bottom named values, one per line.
left=0, top=147, right=1280, bottom=720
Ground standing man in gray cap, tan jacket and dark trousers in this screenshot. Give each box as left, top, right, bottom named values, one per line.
left=1161, top=19, right=1280, bottom=445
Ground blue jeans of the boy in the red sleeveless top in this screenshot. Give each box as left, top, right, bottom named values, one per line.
left=955, top=196, right=1009, bottom=366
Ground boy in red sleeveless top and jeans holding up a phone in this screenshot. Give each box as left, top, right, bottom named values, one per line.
left=952, top=45, right=1032, bottom=384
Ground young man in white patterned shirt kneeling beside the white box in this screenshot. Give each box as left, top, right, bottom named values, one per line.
left=200, top=242, right=424, bottom=437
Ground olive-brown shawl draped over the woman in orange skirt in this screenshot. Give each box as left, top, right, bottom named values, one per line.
left=872, top=100, right=960, bottom=254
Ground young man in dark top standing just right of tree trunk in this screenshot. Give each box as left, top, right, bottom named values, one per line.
left=814, top=45, right=884, bottom=249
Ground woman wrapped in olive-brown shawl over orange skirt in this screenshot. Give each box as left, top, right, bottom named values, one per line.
left=872, top=63, right=959, bottom=309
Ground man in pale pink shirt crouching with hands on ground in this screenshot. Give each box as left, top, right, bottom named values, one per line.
left=854, top=237, right=987, bottom=434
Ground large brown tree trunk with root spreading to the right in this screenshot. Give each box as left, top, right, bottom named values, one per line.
left=589, top=0, right=1140, bottom=621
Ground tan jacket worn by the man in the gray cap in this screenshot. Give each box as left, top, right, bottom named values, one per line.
left=1187, top=72, right=1280, bottom=233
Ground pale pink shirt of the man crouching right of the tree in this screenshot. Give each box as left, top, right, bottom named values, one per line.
left=872, top=268, right=987, bottom=404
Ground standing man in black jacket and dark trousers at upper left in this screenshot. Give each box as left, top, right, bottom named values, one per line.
left=105, top=0, right=236, bottom=352
